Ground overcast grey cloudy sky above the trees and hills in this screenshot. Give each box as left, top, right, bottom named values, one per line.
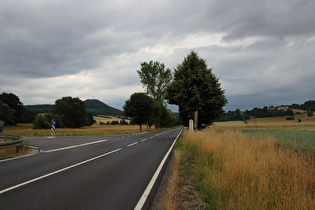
left=0, top=0, right=315, bottom=110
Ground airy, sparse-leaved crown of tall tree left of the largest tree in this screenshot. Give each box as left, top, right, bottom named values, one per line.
left=137, top=61, right=172, bottom=103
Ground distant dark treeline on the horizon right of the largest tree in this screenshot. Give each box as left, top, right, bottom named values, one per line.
left=217, top=101, right=315, bottom=122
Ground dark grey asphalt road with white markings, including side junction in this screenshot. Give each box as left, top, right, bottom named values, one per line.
left=0, top=128, right=182, bottom=210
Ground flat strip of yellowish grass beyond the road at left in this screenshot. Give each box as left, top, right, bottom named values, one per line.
left=3, top=123, right=154, bottom=136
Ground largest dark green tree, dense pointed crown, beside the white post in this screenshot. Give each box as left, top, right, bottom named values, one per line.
left=165, top=51, right=227, bottom=128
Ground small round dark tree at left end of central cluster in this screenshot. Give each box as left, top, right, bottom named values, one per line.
left=123, top=93, right=155, bottom=130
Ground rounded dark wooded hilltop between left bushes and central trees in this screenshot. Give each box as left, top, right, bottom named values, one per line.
left=84, top=99, right=124, bottom=116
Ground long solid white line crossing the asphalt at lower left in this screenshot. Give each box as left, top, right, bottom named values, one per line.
left=0, top=148, right=122, bottom=195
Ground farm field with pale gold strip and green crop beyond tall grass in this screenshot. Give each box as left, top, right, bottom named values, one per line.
left=213, top=114, right=315, bottom=153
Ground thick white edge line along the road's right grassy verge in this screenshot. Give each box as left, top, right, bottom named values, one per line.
left=134, top=130, right=183, bottom=210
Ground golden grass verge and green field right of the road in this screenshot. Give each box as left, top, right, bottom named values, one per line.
left=164, top=111, right=315, bottom=209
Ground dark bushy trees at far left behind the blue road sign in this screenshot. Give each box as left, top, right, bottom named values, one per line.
left=0, top=93, right=95, bottom=129
